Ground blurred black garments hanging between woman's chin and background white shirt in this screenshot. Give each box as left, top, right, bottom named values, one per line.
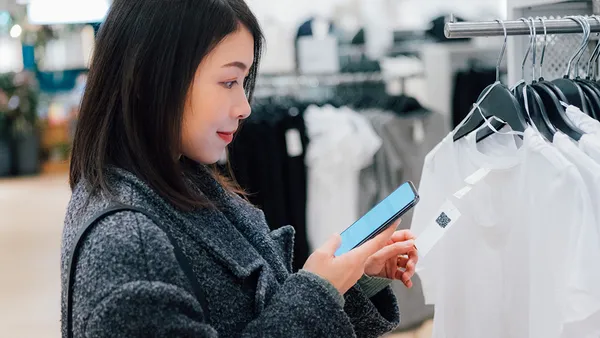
left=229, top=105, right=309, bottom=271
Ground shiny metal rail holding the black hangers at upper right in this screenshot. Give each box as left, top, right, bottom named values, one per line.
left=444, top=17, right=600, bottom=39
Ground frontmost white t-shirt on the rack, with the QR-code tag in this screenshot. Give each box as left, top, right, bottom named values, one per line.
left=412, top=128, right=591, bottom=338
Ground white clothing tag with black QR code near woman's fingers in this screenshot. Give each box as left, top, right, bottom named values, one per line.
left=415, top=200, right=461, bottom=258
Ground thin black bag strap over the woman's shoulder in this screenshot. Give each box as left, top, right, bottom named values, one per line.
left=66, top=204, right=210, bottom=338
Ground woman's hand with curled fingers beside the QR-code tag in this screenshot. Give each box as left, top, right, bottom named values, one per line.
left=365, top=230, right=419, bottom=288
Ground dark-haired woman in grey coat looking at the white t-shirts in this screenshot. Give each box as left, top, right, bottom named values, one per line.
left=62, top=0, right=417, bottom=338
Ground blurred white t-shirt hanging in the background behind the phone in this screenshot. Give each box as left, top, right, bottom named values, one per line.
left=304, top=106, right=382, bottom=250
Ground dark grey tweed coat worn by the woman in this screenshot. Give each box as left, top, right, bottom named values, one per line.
left=61, top=169, right=399, bottom=338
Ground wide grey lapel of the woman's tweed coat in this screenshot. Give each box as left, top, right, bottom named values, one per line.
left=110, top=167, right=293, bottom=313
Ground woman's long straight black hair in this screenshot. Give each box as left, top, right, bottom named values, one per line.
left=70, top=0, right=263, bottom=210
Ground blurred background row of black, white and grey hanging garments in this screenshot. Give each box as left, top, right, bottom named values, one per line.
left=223, top=100, right=448, bottom=327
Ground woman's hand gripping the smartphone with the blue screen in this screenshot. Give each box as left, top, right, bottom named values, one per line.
left=303, top=226, right=396, bottom=295
